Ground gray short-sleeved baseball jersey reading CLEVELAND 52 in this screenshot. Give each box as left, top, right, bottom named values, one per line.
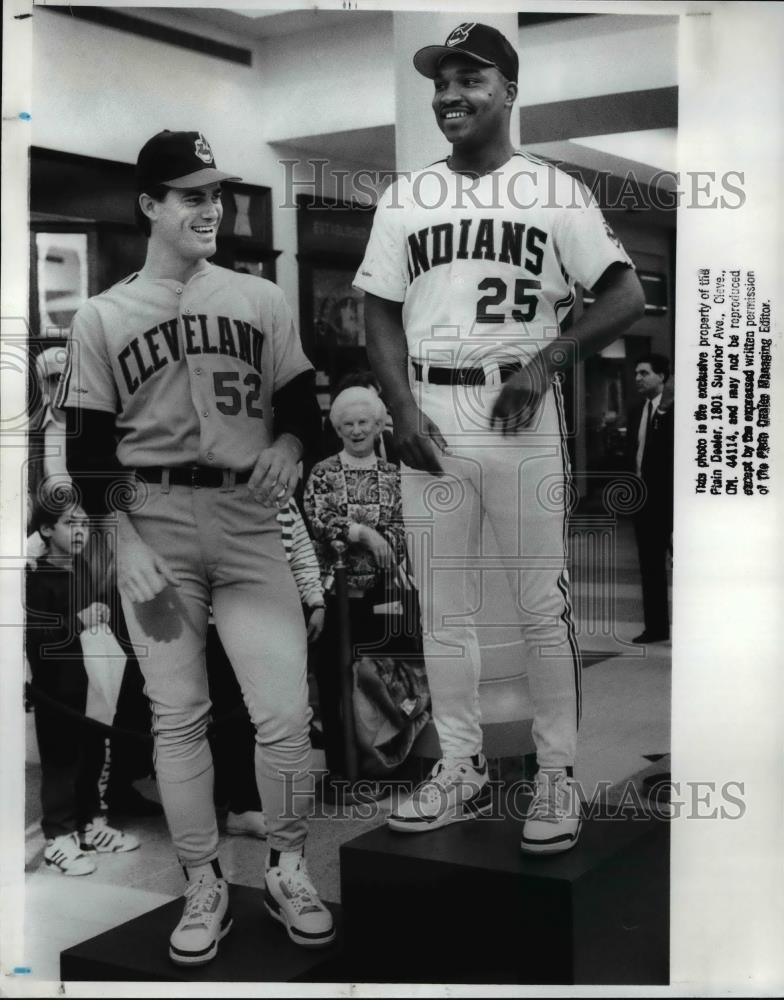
left=58, top=264, right=312, bottom=471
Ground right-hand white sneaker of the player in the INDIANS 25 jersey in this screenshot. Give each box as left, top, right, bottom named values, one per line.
left=520, top=768, right=582, bottom=854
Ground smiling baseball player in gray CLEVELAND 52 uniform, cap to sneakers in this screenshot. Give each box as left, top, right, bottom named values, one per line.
left=59, top=131, right=334, bottom=965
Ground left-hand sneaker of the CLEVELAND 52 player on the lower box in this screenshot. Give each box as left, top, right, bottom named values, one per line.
left=169, top=878, right=232, bottom=965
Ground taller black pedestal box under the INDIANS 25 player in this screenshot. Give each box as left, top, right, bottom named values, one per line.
left=340, top=818, right=669, bottom=985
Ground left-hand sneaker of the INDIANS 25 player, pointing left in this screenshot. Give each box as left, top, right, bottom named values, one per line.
left=387, top=754, right=493, bottom=833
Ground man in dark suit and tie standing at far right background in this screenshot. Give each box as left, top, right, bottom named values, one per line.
left=627, top=354, right=674, bottom=645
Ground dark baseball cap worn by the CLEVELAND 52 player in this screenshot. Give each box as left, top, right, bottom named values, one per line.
left=136, top=129, right=242, bottom=191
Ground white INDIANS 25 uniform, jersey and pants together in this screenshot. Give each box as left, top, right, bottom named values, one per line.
left=354, top=153, right=631, bottom=767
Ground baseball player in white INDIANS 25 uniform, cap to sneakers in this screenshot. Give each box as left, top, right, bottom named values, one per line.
left=355, top=22, right=643, bottom=853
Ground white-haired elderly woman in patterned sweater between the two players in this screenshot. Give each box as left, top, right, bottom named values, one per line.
left=303, top=386, right=407, bottom=773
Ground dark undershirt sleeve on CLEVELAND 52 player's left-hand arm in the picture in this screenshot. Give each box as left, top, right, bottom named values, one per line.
left=65, top=408, right=130, bottom=516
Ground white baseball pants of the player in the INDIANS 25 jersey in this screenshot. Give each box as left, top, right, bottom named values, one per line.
left=401, top=382, right=581, bottom=767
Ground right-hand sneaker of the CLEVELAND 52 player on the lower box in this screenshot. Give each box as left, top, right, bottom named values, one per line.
left=264, top=852, right=335, bottom=948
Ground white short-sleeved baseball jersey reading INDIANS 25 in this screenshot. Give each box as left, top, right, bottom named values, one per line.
left=354, top=153, right=631, bottom=366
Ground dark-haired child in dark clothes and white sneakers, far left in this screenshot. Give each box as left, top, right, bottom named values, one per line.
left=26, top=488, right=139, bottom=875
